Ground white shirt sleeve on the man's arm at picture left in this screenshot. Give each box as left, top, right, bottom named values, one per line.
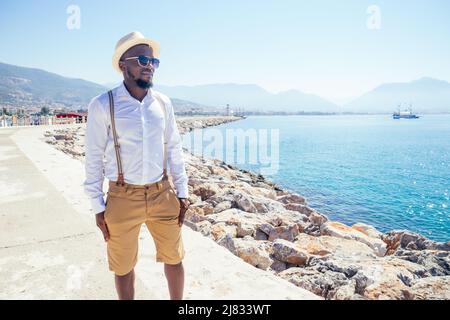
left=84, top=98, right=108, bottom=214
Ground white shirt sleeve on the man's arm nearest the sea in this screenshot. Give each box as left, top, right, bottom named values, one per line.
left=167, top=99, right=188, bottom=198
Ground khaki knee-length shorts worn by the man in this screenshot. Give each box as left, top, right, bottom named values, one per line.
left=105, top=180, right=185, bottom=275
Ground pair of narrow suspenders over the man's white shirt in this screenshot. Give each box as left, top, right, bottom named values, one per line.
left=108, top=90, right=168, bottom=186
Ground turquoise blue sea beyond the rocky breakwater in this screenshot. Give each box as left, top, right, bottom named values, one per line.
left=185, top=115, right=450, bottom=241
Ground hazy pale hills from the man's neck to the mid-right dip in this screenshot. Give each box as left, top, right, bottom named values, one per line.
left=155, top=83, right=340, bottom=112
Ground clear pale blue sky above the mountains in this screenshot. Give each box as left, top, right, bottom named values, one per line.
left=0, top=0, right=450, bottom=101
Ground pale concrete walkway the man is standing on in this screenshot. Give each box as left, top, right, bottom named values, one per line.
left=0, top=126, right=318, bottom=299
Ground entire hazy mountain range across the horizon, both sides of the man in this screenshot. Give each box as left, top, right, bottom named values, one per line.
left=0, top=63, right=450, bottom=113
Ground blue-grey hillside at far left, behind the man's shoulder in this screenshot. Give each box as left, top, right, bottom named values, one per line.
left=0, top=63, right=106, bottom=106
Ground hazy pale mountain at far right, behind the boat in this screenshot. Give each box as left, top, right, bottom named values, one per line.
left=343, top=77, right=450, bottom=113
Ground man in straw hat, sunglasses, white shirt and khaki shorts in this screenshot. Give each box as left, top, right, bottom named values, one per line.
left=84, top=32, right=189, bottom=299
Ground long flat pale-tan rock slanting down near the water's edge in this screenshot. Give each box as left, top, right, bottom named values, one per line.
left=320, top=221, right=387, bottom=257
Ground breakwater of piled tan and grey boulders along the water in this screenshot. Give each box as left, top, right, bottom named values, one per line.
left=47, top=117, right=450, bottom=299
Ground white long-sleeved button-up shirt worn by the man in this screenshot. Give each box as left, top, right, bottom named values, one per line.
left=84, top=83, right=188, bottom=213
